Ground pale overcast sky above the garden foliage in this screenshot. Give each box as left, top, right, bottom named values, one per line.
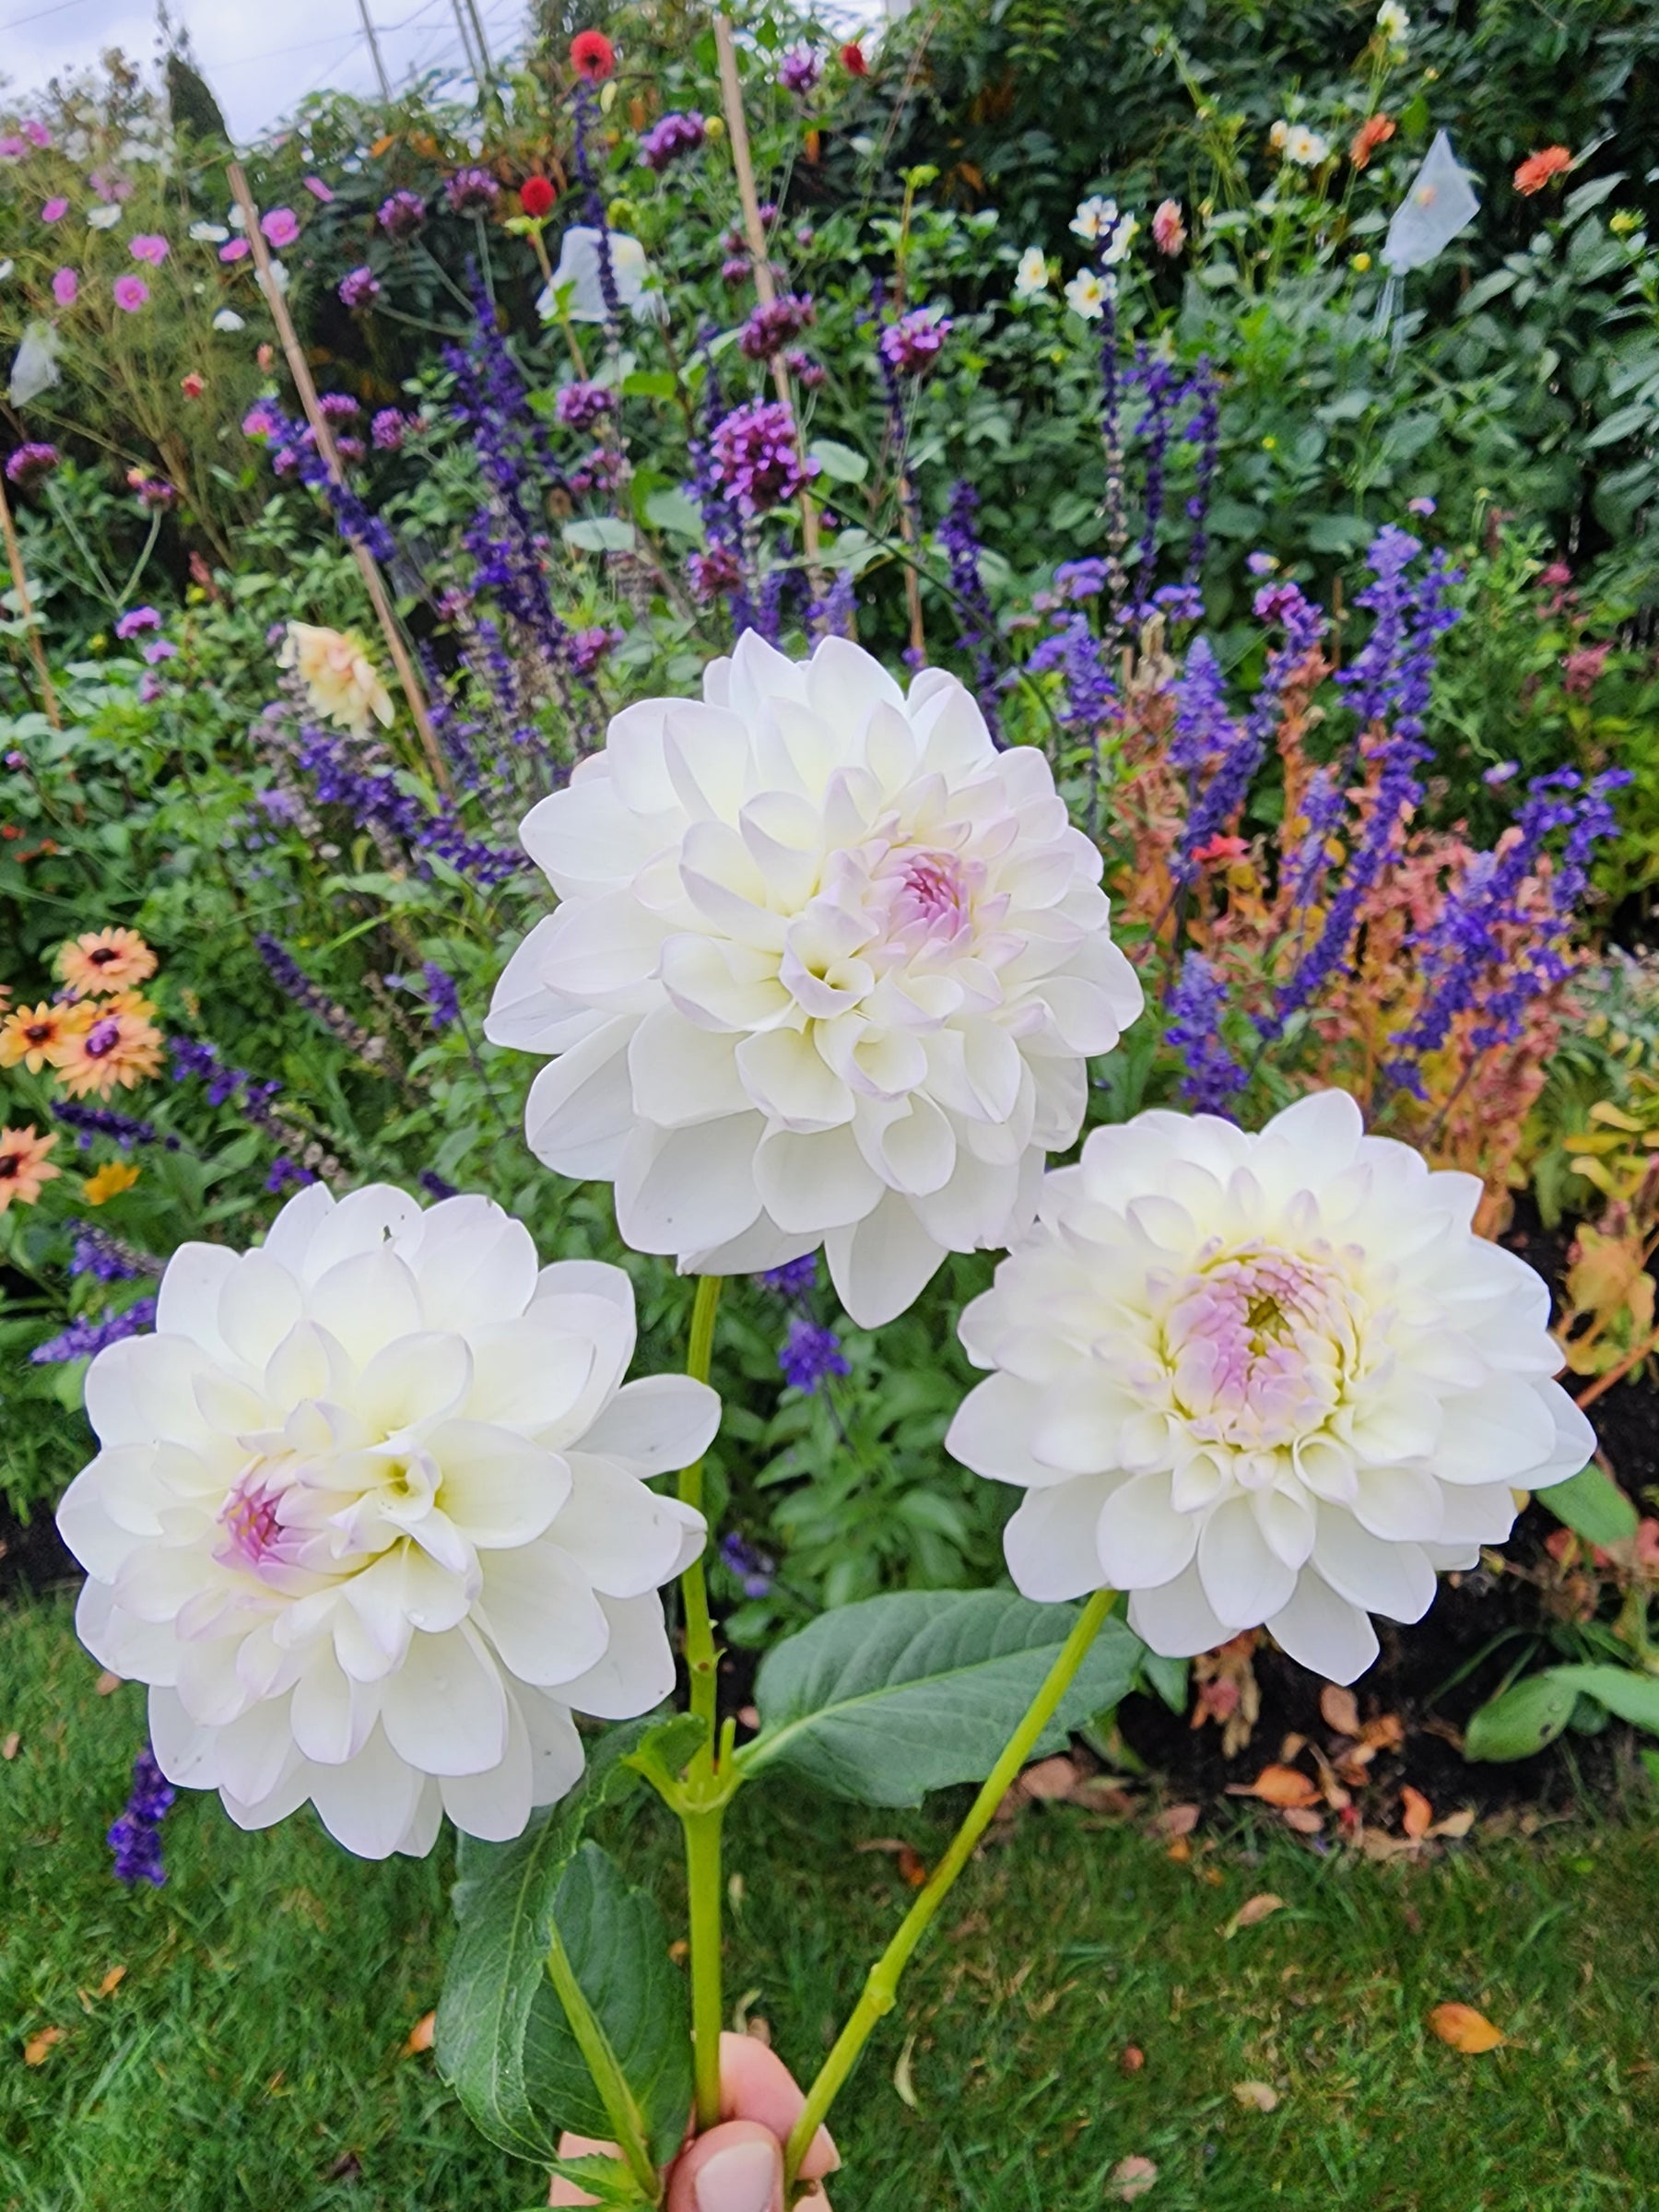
left=0, top=0, right=898, bottom=139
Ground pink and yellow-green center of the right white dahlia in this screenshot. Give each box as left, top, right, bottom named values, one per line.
left=1163, top=1250, right=1354, bottom=1451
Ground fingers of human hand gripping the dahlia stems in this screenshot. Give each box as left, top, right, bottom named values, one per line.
left=548, top=2035, right=841, bottom=2212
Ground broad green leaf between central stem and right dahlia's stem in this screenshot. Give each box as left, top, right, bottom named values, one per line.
left=739, top=1591, right=1141, bottom=1805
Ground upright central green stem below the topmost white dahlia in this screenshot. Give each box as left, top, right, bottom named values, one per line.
left=677, top=1274, right=730, bottom=2133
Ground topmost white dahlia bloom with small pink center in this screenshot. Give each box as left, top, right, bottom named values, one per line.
left=487, top=632, right=1141, bottom=1327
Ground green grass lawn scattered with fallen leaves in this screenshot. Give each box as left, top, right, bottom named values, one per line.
left=0, top=1602, right=1659, bottom=2212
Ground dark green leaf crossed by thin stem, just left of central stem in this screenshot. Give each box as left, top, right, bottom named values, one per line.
left=524, top=1842, right=692, bottom=2166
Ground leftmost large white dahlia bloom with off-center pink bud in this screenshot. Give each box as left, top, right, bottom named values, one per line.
left=57, top=1183, right=719, bottom=1858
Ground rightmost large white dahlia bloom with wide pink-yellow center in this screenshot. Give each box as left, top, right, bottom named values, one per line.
left=947, top=1090, right=1594, bottom=1681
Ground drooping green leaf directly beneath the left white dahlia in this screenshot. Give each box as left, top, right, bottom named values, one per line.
left=436, top=1725, right=646, bottom=2159
